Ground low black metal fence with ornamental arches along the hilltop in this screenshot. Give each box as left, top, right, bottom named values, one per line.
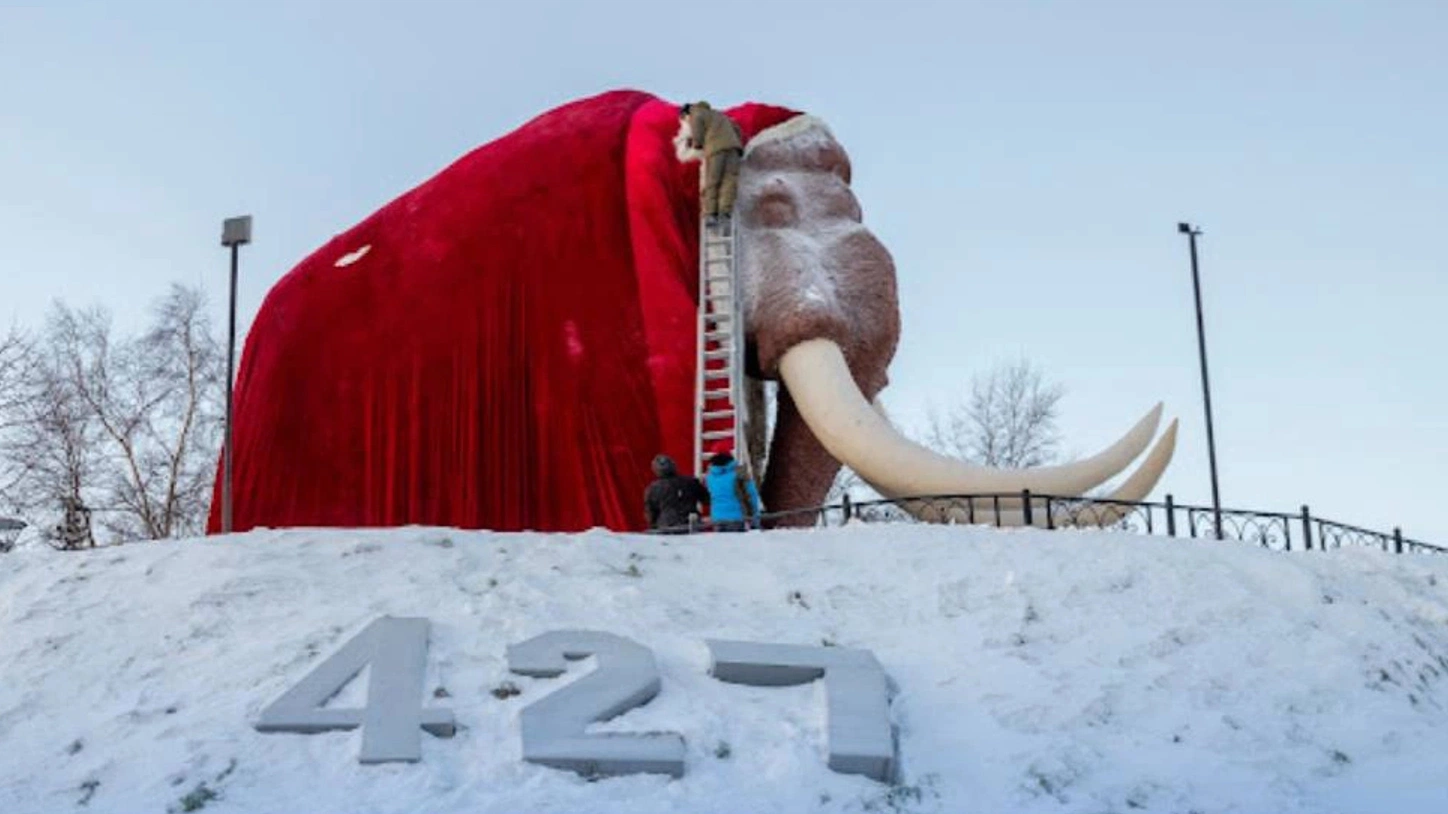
left=660, top=491, right=1448, bottom=553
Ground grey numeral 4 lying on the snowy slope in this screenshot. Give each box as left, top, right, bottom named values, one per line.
left=255, top=617, right=455, bottom=763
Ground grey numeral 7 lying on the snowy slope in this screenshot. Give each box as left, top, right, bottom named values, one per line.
left=705, top=639, right=895, bottom=782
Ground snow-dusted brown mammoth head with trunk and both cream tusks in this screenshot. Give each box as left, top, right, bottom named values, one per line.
left=724, top=116, right=1176, bottom=521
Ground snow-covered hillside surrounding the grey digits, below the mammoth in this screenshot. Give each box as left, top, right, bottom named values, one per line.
left=0, top=526, right=1448, bottom=814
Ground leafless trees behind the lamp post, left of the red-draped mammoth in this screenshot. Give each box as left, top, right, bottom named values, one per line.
left=4, top=285, right=224, bottom=539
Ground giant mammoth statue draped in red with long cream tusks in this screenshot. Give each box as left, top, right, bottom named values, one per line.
left=210, top=91, right=1176, bottom=532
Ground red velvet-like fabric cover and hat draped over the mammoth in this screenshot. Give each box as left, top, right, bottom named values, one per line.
left=210, top=91, right=795, bottom=533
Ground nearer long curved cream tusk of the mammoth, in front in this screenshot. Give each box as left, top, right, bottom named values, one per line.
left=779, top=339, right=1170, bottom=497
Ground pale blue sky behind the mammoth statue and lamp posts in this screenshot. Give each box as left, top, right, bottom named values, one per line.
left=0, top=0, right=1448, bottom=543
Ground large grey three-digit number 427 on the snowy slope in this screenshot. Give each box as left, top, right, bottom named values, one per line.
left=255, top=617, right=896, bottom=782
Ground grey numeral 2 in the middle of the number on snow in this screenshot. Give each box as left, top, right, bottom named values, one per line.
left=508, top=630, right=683, bottom=778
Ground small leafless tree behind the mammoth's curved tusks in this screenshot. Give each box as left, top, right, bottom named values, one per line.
left=924, top=359, right=1064, bottom=469
